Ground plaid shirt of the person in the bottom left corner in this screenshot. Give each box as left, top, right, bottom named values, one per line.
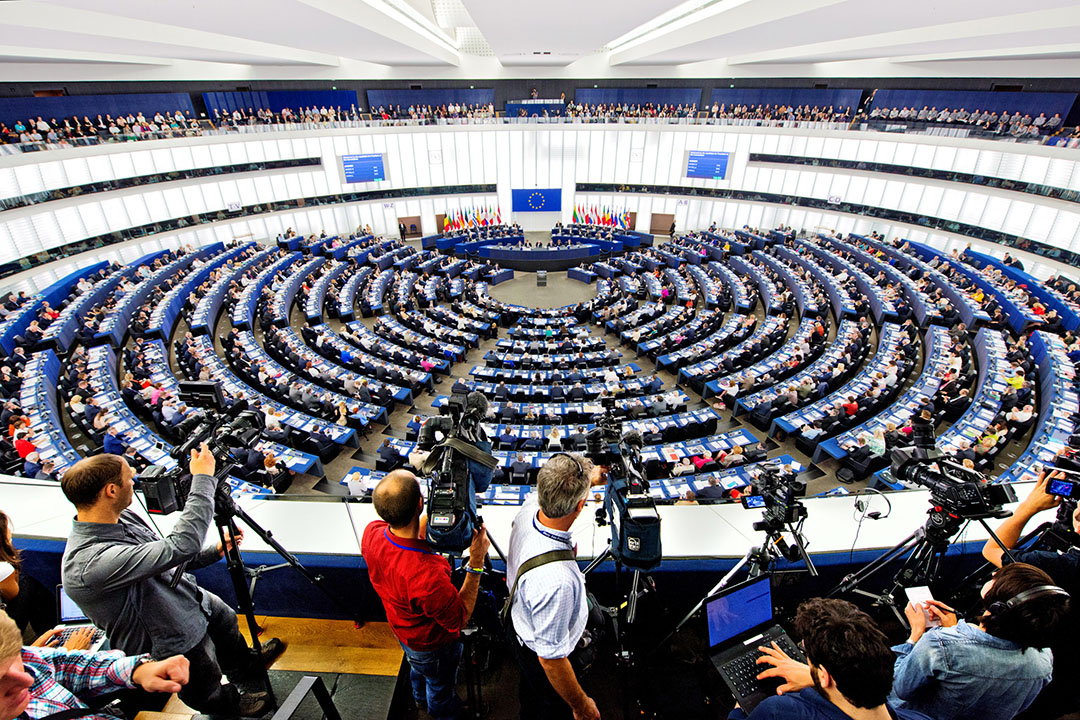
left=18, top=647, right=150, bottom=720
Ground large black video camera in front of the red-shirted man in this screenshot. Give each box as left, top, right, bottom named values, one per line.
left=418, top=391, right=498, bottom=553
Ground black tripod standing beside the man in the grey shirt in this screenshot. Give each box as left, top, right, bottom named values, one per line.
left=214, top=468, right=364, bottom=706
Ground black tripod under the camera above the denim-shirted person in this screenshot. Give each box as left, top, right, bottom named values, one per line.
left=828, top=507, right=1013, bottom=627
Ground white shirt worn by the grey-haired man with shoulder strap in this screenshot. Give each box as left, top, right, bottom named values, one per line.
left=507, top=492, right=589, bottom=660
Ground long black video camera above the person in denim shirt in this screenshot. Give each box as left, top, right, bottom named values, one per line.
left=891, top=447, right=1016, bottom=520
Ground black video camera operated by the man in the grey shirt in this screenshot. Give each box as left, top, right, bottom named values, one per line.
left=139, top=382, right=262, bottom=515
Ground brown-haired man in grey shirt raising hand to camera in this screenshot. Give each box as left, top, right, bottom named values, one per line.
left=60, top=444, right=284, bottom=717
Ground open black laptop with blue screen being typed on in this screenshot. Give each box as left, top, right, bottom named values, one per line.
left=705, top=575, right=806, bottom=715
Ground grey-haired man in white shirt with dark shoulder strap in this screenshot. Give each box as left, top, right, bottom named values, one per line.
left=507, top=452, right=604, bottom=720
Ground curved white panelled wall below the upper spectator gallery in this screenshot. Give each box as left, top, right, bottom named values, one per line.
left=0, top=125, right=1080, bottom=274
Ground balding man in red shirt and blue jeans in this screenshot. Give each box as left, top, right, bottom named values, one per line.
left=361, top=470, right=489, bottom=719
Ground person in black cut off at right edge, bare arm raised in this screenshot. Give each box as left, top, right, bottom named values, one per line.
left=983, top=471, right=1080, bottom=719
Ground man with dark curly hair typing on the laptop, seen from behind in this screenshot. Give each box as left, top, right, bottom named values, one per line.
left=728, top=598, right=927, bottom=720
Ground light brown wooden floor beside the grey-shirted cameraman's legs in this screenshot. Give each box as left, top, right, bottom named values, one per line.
left=136, top=615, right=403, bottom=720
